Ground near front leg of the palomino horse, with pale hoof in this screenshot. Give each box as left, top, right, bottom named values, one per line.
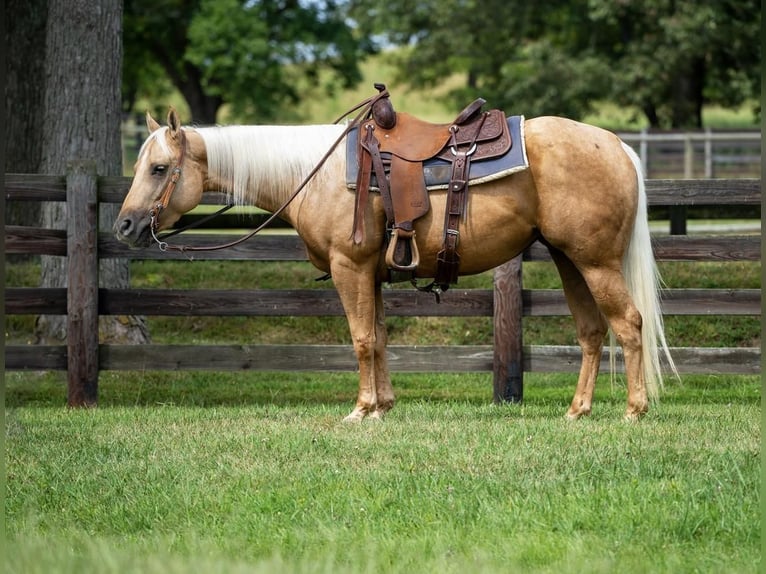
left=331, top=257, right=393, bottom=422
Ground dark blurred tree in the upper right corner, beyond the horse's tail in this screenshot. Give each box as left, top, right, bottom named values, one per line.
left=590, top=0, right=761, bottom=128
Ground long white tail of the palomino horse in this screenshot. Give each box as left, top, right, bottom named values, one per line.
left=622, top=142, right=678, bottom=401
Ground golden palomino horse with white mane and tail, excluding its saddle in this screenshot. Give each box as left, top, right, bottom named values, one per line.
left=114, top=110, right=673, bottom=421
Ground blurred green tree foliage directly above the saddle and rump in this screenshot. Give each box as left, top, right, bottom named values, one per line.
left=350, top=0, right=606, bottom=117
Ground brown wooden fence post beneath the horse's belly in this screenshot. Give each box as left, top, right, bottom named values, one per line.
left=493, top=255, right=524, bottom=403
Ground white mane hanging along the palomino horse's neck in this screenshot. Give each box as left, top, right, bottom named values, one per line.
left=195, top=125, right=344, bottom=204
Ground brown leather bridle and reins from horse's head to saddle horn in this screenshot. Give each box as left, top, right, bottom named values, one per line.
left=149, top=90, right=389, bottom=253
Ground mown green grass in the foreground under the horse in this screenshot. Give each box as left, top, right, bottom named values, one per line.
left=4, top=373, right=760, bottom=573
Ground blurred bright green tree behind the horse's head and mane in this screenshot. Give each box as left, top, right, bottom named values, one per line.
left=123, top=0, right=376, bottom=124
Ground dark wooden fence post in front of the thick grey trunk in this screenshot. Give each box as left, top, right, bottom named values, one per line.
left=66, top=160, right=98, bottom=407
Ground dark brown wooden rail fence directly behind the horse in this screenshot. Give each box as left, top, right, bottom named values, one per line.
left=5, top=171, right=761, bottom=406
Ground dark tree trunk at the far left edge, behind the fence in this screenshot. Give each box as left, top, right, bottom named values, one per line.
left=4, top=0, right=48, bottom=230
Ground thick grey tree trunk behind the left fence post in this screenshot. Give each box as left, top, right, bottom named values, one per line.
left=36, top=0, right=148, bottom=342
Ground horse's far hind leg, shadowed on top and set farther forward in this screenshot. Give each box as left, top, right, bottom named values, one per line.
left=549, top=248, right=608, bottom=419
